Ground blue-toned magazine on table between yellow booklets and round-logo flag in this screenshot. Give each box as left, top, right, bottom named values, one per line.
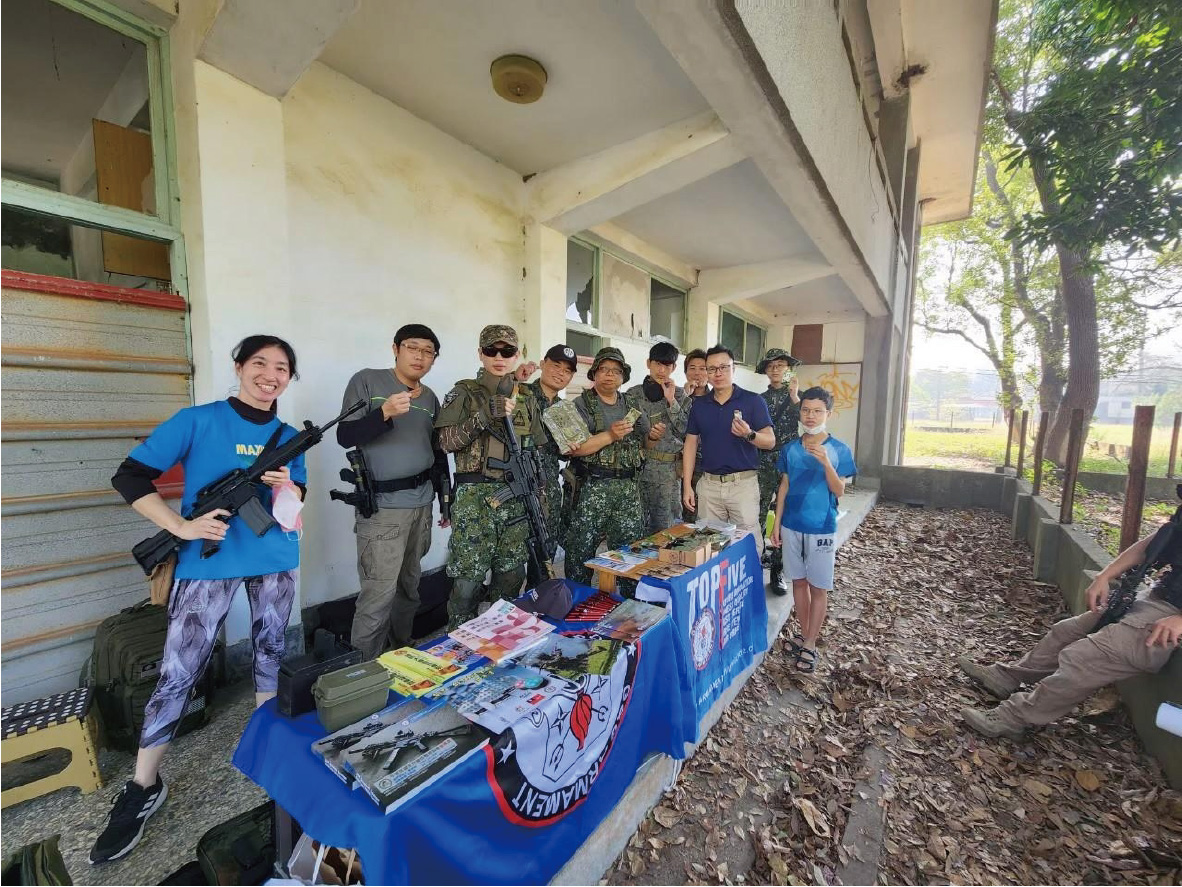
left=430, top=662, right=578, bottom=733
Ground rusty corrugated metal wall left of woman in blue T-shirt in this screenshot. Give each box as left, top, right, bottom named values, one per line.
left=0, top=271, right=191, bottom=705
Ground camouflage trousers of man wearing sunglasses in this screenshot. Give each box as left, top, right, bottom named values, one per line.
left=447, top=484, right=530, bottom=582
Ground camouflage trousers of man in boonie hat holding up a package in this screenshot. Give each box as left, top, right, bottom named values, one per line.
left=563, top=478, right=645, bottom=585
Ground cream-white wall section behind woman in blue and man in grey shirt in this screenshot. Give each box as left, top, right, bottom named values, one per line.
left=282, top=64, right=526, bottom=607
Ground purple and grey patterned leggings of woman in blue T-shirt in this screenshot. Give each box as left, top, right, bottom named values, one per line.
left=139, top=570, right=299, bottom=749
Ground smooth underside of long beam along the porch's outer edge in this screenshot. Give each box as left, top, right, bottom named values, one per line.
left=636, top=0, right=890, bottom=317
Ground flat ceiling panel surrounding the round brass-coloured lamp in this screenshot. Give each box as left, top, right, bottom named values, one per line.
left=319, top=0, right=708, bottom=175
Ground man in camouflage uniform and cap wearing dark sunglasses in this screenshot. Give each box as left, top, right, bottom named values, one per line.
left=435, top=324, right=544, bottom=628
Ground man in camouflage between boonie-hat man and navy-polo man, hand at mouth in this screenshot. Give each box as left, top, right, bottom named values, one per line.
left=628, top=342, right=690, bottom=536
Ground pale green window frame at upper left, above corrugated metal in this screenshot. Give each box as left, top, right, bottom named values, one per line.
left=0, top=0, right=188, bottom=296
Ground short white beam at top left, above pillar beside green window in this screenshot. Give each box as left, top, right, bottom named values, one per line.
left=197, top=0, right=361, bottom=98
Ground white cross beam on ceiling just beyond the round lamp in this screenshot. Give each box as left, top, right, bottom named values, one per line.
left=526, top=111, right=746, bottom=235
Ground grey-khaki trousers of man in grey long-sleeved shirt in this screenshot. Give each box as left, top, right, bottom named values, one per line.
left=351, top=505, right=431, bottom=660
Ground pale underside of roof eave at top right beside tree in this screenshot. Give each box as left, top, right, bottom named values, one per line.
left=903, top=0, right=998, bottom=225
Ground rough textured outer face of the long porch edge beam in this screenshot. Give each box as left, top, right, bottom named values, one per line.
left=735, top=0, right=895, bottom=303
